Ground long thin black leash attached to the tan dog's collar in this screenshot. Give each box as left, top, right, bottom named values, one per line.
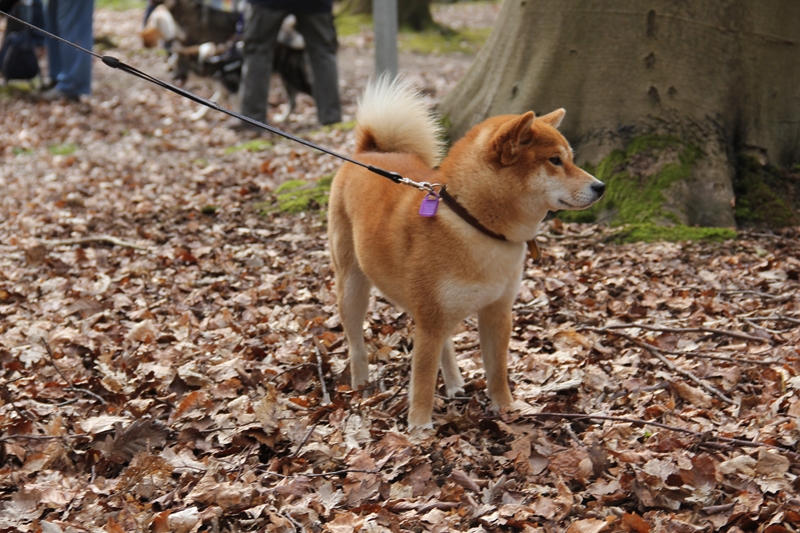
left=0, top=11, right=424, bottom=192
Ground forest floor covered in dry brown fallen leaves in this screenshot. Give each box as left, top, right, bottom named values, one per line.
left=0, top=4, right=800, bottom=533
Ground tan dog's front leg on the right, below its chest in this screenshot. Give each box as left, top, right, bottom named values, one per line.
left=478, top=297, right=513, bottom=409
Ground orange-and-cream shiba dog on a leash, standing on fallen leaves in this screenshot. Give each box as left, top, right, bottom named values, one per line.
left=328, top=78, right=605, bottom=428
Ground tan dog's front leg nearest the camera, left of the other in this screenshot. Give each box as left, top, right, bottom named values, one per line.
left=408, top=325, right=447, bottom=428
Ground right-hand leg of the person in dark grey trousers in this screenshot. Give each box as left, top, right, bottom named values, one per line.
left=297, top=13, right=342, bottom=124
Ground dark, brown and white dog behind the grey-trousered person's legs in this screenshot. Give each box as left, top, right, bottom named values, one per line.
left=140, top=0, right=312, bottom=122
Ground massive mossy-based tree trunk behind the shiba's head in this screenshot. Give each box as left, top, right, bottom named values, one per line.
left=441, top=0, right=800, bottom=226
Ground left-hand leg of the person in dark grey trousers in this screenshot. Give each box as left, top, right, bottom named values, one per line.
left=239, top=4, right=286, bottom=122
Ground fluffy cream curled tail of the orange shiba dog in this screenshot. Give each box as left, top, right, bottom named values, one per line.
left=356, top=76, right=444, bottom=168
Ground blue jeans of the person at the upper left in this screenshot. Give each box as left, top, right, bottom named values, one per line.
left=46, top=0, right=94, bottom=95
